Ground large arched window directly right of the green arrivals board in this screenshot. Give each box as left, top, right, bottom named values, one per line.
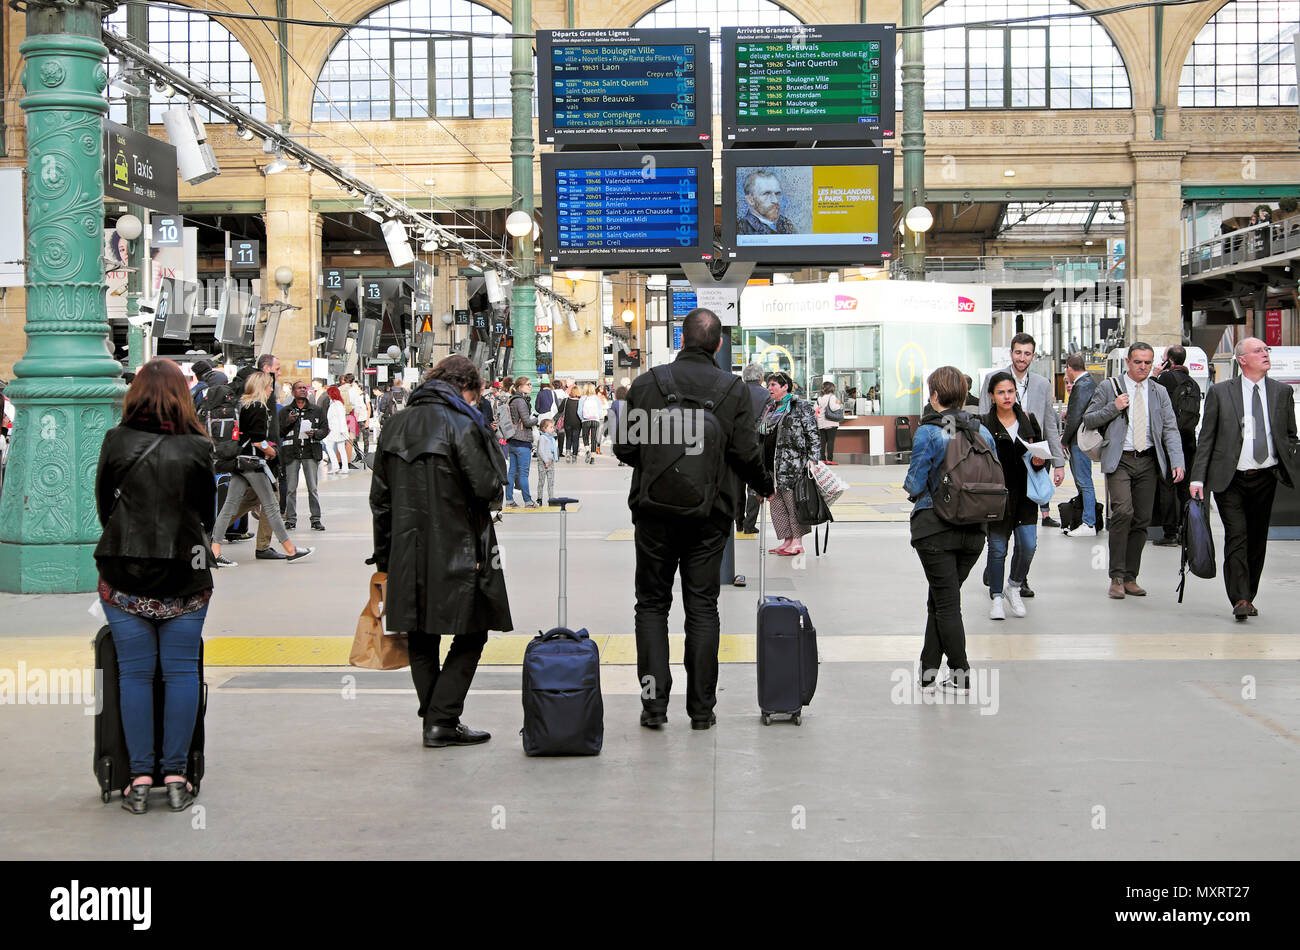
left=897, top=0, right=1132, bottom=110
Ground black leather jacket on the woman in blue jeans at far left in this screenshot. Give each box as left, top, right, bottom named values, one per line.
left=95, top=422, right=217, bottom=597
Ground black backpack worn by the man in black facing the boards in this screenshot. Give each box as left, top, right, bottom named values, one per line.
left=631, top=366, right=738, bottom=517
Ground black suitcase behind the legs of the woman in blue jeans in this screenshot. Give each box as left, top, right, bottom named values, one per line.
left=94, top=624, right=208, bottom=804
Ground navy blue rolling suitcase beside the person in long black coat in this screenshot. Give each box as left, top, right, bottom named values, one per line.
left=519, top=498, right=605, bottom=755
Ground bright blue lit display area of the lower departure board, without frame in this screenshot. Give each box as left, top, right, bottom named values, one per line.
left=555, top=162, right=699, bottom=251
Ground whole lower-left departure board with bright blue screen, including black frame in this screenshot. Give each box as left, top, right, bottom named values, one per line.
left=542, top=152, right=714, bottom=264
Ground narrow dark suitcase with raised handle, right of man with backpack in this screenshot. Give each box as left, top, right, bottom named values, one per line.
left=758, top=502, right=818, bottom=725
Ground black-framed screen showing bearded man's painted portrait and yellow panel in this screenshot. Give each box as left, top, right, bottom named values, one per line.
left=723, top=149, right=893, bottom=263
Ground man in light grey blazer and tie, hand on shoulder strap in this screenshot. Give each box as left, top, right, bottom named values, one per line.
left=1083, top=343, right=1186, bottom=600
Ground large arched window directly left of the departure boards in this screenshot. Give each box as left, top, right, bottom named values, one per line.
left=312, top=0, right=537, bottom=122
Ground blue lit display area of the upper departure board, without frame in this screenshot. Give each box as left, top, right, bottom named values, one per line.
left=551, top=44, right=696, bottom=129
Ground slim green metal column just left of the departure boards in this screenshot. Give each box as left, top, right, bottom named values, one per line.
left=510, top=0, right=537, bottom=376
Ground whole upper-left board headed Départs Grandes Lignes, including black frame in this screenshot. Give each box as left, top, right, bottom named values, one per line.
left=537, top=29, right=712, bottom=146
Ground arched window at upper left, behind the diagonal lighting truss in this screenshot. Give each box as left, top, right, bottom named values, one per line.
left=104, top=4, right=267, bottom=125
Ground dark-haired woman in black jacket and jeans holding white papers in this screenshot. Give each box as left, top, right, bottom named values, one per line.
left=983, top=372, right=1048, bottom=620
